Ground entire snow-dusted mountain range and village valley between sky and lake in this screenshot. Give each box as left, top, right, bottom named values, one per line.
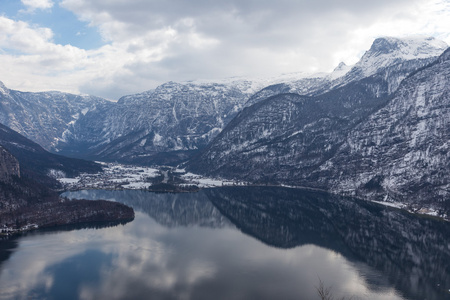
left=0, top=37, right=450, bottom=227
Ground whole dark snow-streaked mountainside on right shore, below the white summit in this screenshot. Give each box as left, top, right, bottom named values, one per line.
left=188, top=42, right=450, bottom=214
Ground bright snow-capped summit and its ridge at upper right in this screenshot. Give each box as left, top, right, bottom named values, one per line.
left=246, top=36, right=448, bottom=106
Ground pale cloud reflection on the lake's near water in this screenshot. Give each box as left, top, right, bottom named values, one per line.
left=0, top=209, right=398, bottom=299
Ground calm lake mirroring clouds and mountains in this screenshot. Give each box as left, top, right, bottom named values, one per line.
left=0, top=187, right=450, bottom=300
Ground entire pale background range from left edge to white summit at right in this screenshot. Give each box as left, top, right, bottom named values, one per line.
left=0, top=38, right=446, bottom=168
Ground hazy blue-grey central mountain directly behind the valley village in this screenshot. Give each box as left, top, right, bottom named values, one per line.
left=57, top=81, right=260, bottom=164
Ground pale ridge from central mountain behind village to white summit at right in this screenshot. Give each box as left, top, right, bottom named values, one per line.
left=55, top=38, right=446, bottom=164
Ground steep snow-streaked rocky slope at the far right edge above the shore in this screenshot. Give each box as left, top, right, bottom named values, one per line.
left=317, top=50, right=450, bottom=206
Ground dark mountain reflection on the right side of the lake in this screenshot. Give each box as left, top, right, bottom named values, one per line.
left=205, top=187, right=450, bottom=299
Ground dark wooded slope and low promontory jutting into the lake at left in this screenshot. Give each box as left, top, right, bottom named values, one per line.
left=0, top=146, right=134, bottom=236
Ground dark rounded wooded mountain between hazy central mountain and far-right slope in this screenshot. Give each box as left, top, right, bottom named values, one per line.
left=188, top=76, right=389, bottom=185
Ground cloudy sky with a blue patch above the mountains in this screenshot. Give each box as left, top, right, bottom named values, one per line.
left=0, top=0, right=450, bottom=100
